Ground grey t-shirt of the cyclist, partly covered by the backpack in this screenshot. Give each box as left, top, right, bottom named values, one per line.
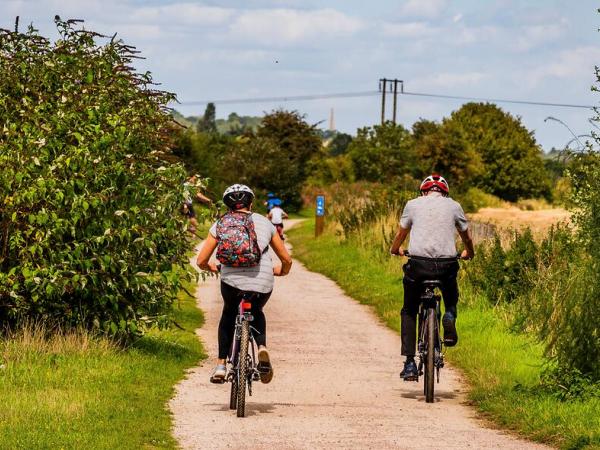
left=210, top=213, right=276, bottom=294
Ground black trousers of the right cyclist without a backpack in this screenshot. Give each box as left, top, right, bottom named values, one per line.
left=400, top=258, right=459, bottom=356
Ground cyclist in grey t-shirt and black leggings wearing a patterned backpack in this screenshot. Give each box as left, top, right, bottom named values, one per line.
left=196, top=184, right=292, bottom=383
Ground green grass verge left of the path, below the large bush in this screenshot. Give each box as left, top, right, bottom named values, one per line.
left=0, top=285, right=204, bottom=449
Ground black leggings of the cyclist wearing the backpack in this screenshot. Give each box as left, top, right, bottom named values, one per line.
left=219, top=281, right=271, bottom=359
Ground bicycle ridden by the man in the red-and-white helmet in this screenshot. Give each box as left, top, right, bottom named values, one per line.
left=405, top=252, right=460, bottom=403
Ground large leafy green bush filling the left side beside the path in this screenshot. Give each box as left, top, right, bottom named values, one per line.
left=0, top=17, right=191, bottom=334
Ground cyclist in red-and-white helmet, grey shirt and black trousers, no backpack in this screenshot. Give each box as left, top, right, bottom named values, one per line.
left=390, top=174, right=475, bottom=381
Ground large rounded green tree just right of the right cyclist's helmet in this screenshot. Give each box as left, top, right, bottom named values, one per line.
left=441, top=103, right=550, bottom=201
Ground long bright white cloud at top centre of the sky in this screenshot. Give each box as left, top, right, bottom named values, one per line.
left=229, top=9, right=364, bottom=46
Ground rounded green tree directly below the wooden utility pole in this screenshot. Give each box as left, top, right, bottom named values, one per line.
left=348, top=122, right=419, bottom=182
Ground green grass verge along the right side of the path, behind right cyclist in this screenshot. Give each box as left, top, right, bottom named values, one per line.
left=289, top=220, right=600, bottom=449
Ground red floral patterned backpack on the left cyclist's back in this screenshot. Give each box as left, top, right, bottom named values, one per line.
left=217, top=211, right=262, bottom=267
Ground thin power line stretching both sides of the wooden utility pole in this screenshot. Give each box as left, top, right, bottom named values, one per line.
left=179, top=91, right=594, bottom=109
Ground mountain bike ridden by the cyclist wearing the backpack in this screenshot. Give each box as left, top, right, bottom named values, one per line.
left=226, top=294, right=260, bottom=417
